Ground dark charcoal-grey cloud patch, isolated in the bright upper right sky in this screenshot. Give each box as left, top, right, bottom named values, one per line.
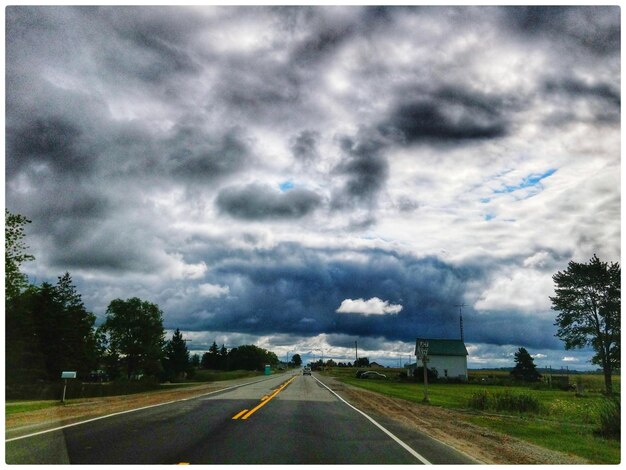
left=379, top=88, right=507, bottom=144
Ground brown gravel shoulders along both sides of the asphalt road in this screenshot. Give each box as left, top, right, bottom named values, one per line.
left=5, top=377, right=589, bottom=465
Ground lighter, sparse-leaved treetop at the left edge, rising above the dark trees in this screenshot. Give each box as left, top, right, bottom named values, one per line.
left=4, top=209, right=35, bottom=302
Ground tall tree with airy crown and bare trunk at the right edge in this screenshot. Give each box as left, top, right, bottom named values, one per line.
left=550, top=254, right=621, bottom=395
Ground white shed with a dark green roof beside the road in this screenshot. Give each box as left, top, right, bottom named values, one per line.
left=415, top=338, right=467, bottom=380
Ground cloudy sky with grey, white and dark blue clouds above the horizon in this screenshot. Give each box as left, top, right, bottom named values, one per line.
left=5, top=6, right=621, bottom=369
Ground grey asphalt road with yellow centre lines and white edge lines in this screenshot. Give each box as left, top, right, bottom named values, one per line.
left=5, top=373, right=471, bottom=464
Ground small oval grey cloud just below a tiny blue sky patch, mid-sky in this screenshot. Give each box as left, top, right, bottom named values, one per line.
left=215, top=183, right=322, bottom=220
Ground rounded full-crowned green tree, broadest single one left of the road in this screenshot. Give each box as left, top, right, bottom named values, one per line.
left=102, top=297, right=165, bottom=378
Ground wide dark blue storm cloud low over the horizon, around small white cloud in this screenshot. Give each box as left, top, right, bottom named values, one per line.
left=176, top=243, right=558, bottom=347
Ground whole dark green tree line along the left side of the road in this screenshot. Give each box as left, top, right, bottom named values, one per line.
left=5, top=209, right=278, bottom=385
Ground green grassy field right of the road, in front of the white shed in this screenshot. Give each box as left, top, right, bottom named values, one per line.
left=324, top=368, right=620, bottom=464
